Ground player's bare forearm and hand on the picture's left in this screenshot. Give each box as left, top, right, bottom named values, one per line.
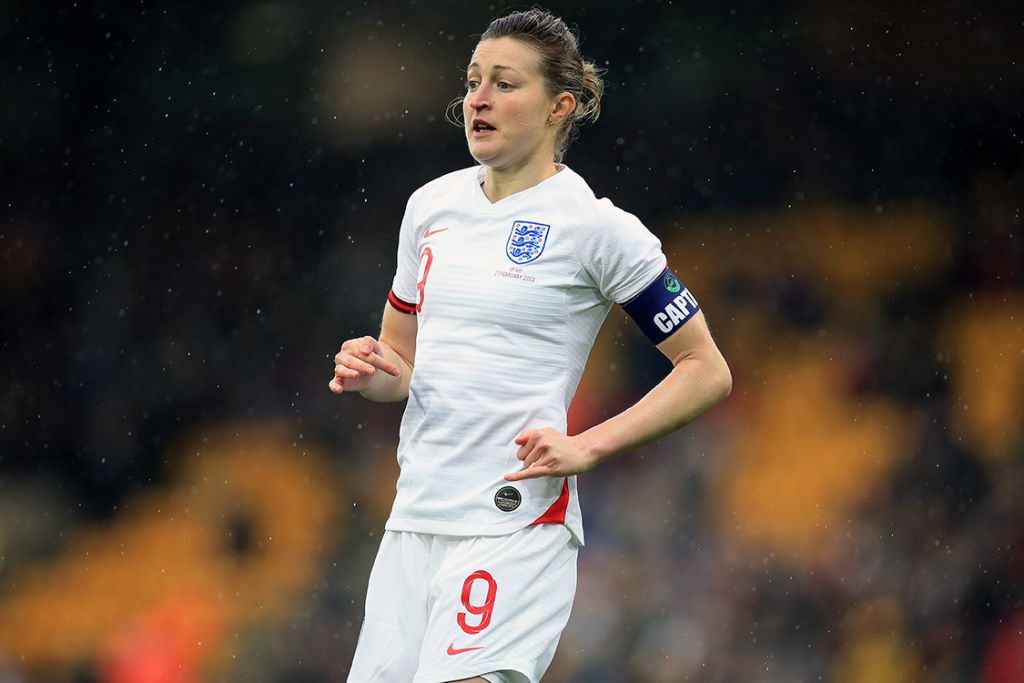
left=329, top=304, right=417, bottom=402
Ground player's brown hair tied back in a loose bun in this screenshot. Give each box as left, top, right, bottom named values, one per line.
left=459, top=7, right=604, bottom=162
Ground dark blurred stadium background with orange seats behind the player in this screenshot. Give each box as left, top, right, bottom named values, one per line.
left=0, top=0, right=1024, bottom=683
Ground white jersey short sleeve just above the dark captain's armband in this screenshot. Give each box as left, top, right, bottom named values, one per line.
left=577, top=200, right=667, bottom=303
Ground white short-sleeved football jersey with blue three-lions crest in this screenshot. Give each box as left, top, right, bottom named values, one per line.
left=387, top=166, right=666, bottom=543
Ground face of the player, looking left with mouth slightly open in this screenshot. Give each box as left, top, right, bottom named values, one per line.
left=462, top=38, right=557, bottom=169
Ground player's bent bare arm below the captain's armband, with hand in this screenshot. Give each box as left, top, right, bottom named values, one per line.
left=505, top=311, right=732, bottom=481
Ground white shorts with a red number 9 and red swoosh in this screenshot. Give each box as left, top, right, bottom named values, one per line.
left=348, top=524, right=579, bottom=683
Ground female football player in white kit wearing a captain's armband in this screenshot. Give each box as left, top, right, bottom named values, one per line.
left=330, top=9, right=732, bottom=683
